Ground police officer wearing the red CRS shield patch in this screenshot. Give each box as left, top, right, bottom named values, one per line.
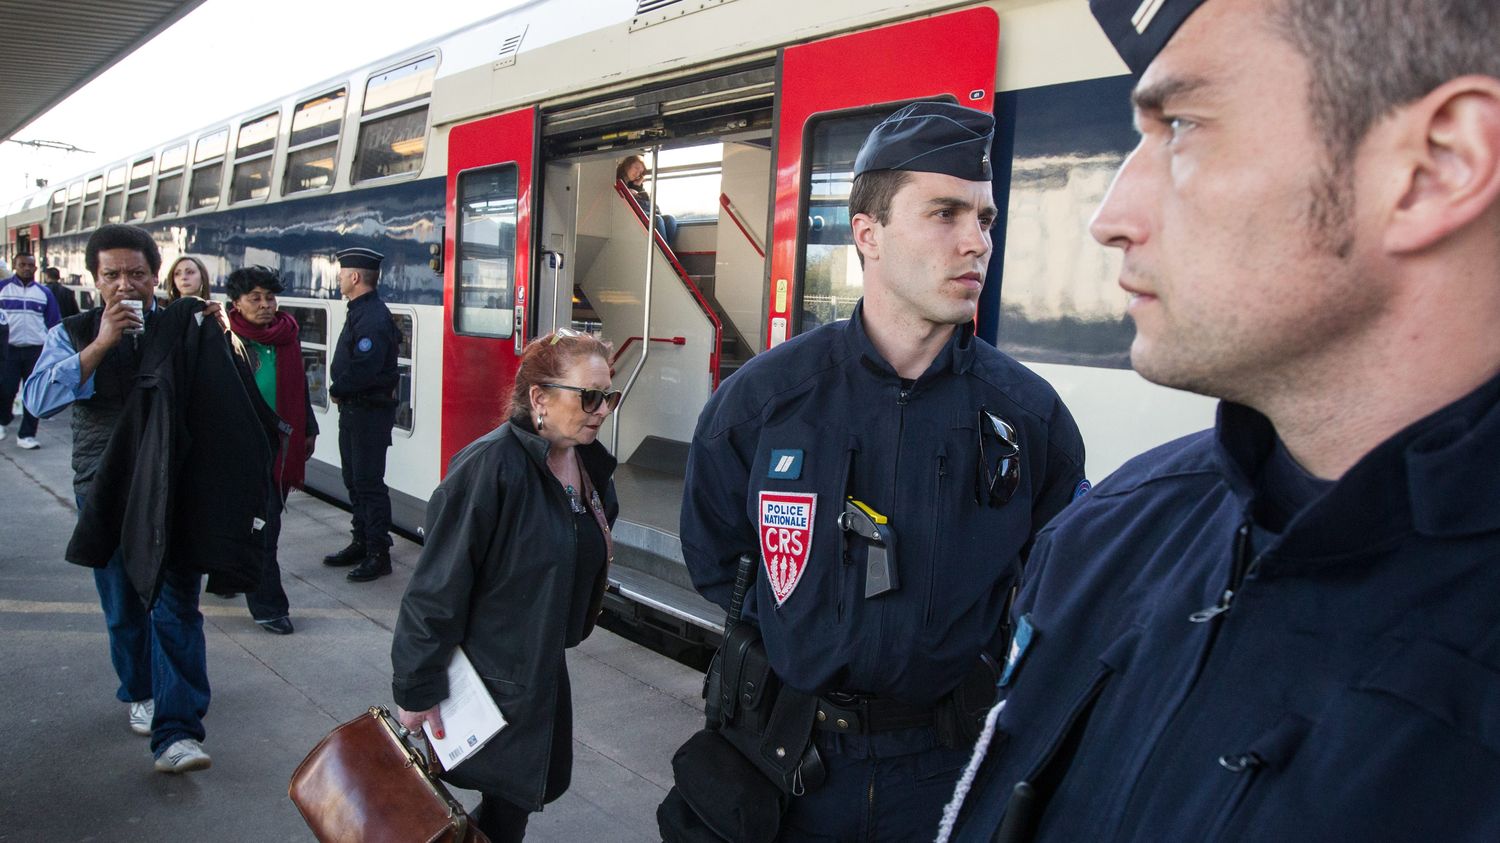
left=681, top=102, right=1088, bottom=840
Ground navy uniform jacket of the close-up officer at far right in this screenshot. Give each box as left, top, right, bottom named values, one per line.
left=954, top=380, right=1500, bottom=842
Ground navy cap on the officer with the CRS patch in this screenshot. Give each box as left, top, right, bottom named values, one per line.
left=854, top=102, right=995, bottom=182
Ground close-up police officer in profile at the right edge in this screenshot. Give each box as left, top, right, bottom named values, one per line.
left=945, top=0, right=1500, bottom=842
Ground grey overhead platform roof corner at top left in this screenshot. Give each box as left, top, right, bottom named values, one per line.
left=0, top=0, right=203, bottom=141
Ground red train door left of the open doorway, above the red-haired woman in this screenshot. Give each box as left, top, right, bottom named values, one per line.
left=441, top=108, right=539, bottom=465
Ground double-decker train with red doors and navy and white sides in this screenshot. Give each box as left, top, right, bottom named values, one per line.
left=0, top=0, right=1212, bottom=639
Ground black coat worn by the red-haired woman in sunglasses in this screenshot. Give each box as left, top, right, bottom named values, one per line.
left=392, top=423, right=620, bottom=810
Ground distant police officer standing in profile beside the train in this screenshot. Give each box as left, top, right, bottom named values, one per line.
left=323, top=249, right=401, bottom=582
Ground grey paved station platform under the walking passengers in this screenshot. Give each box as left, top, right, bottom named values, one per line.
left=0, top=413, right=702, bottom=842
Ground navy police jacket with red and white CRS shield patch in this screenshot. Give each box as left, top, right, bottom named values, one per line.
left=681, top=305, right=1083, bottom=705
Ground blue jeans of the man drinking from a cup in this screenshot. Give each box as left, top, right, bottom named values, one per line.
left=84, top=492, right=209, bottom=747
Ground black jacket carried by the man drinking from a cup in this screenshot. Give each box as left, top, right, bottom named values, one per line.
left=66, top=297, right=279, bottom=605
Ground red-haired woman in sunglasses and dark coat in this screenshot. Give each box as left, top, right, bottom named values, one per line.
left=392, top=329, right=620, bottom=843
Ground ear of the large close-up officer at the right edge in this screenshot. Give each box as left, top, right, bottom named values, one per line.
left=1385, top=75, right=1500, bottom=254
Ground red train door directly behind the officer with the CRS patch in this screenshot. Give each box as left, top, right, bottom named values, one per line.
left=765, top=8, right=1001, bottom=348
